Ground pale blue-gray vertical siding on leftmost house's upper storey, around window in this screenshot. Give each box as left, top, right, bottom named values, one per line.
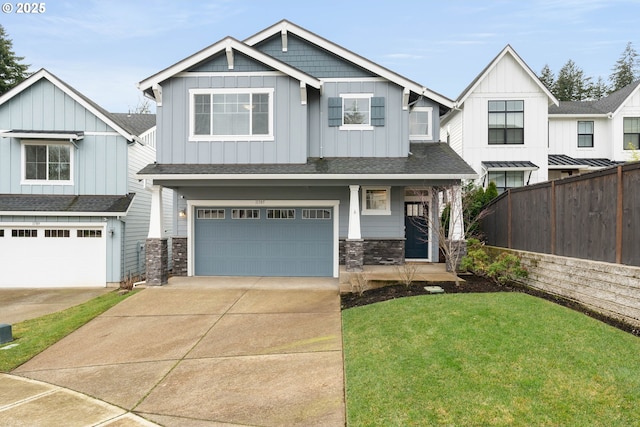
left=0, top=79, right=128, bottom=195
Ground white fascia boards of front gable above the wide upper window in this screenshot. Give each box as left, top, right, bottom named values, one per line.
left=138, top=37, right=321, bottom=92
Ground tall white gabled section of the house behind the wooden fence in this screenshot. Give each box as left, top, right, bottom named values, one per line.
left=440, top=45, right=558, bottom=192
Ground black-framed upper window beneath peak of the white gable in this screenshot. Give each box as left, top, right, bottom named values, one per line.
left=489, top=101, right=524, bottom=144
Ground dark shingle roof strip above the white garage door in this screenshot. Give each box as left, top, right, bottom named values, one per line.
left=0, top=194, right=134, bottom=214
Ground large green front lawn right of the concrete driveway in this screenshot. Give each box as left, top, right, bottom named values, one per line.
left=343, top=293, right=640, bottom=427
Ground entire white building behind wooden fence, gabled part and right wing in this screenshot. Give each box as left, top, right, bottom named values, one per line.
left=440, top=46, right=640, bottom=192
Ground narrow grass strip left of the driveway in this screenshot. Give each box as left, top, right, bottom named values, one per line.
left=0, top=291, right=135, bottom=372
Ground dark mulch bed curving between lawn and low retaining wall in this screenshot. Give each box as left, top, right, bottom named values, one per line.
left=340, top=274, right=640, bottom=336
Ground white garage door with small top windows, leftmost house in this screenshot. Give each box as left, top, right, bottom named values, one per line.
left=0, top=224, right=106, bottom=287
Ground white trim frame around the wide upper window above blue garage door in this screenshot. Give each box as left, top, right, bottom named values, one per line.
left=189, top=88, right=275, bottom=141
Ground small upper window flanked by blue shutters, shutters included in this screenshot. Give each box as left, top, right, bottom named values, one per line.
left=328, top=93, right=385, bottom=130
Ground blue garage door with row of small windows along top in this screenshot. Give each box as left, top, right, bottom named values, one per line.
left=194, top=207, right=333, bottom=276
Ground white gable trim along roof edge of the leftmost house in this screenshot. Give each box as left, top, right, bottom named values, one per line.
left=0, top=68, right=136, bottom=141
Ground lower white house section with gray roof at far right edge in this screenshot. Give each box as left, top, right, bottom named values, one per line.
left=549, top=80, right=640, bottom=179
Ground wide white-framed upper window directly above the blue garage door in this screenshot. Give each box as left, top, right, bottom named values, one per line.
left=189, top=89, right=273, bottom=141
